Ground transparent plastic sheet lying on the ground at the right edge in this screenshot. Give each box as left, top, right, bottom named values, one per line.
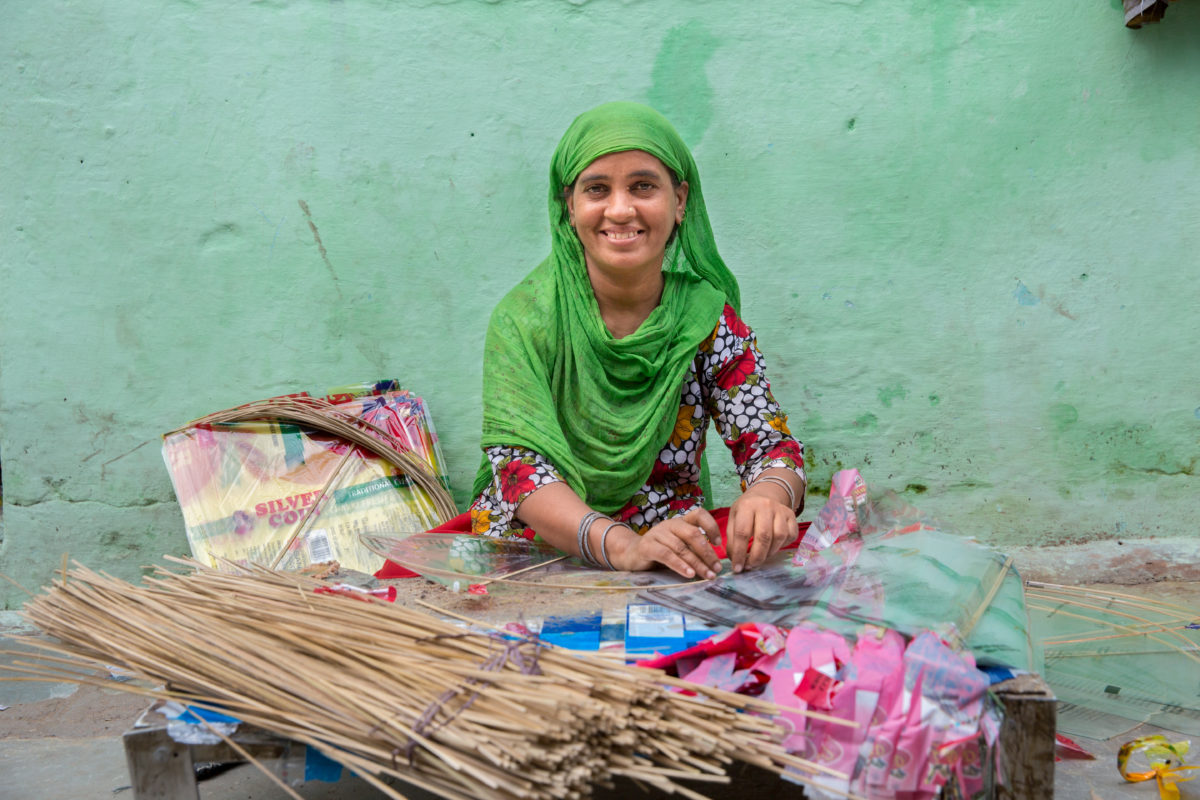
left=1027, top=582, right=1200, bottom=739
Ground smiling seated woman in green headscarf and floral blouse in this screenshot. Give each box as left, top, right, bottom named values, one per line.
left=470, top=103, right=805, bottom=578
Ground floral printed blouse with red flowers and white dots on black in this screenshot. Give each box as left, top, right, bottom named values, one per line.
left=470, top=305, right=806, bottom=536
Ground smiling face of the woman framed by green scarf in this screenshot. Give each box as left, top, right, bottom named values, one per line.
left=566, top=150, right=688, bottom=286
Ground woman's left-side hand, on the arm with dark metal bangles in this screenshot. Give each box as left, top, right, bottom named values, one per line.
left=609, top=509, right=720, bottom=578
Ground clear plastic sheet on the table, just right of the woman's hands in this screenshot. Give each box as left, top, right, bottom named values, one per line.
left=642, top=495, right=1037, bottom=670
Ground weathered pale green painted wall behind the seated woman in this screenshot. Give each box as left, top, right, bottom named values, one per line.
left=0, top=0, right=1200, bottom=606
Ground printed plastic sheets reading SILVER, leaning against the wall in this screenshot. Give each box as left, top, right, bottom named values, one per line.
left=163, top=381, right=446, bottom=572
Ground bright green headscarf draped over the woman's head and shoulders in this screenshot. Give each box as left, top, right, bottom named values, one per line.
left=474, top=102, right=739, bottom=513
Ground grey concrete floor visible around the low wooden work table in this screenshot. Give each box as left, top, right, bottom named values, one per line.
left=0, top=583, right=1200, bottom=800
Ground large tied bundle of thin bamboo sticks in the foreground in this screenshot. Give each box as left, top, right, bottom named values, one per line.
left=9, top=561, right=844, bottom=800
